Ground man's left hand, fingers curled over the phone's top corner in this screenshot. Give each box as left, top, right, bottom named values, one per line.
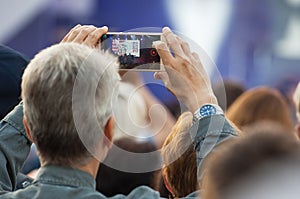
left=61, top=25, right=108, bottom=48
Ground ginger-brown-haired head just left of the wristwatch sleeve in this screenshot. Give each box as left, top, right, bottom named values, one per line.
left=161, top=112, right=199, bottom=198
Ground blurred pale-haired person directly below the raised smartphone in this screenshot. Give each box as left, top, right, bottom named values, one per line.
left=114, top=71, right=175, bottom=149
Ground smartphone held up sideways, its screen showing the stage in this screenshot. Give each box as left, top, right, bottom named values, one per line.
left=101, top=32, right=162, bottom=71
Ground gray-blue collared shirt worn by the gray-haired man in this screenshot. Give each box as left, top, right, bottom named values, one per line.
left=0, top=104, right=236, bottom=199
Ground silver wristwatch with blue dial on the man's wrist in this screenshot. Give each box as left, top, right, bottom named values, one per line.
left=193, top=104, right=224, bottom=122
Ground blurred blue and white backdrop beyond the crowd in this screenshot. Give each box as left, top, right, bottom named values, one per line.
left=0, top=0, right=300, bottom=101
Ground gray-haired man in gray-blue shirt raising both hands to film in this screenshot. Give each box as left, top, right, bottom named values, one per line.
left=0, top=25, right=236, bottom=198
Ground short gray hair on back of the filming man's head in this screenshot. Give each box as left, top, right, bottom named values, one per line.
left=22, top=43, right=118, bottom=166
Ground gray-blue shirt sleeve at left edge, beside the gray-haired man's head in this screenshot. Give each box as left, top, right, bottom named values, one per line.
left=0, top=103, right=31, bottom=192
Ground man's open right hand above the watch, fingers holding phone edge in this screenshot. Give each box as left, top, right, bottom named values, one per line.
left=153, top=28, right=218, bottom=112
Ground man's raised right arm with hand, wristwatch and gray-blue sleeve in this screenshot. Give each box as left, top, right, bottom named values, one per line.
left=154, top=28, right=237, bottom=177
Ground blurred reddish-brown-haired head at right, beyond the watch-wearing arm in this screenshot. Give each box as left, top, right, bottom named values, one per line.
left=226, top=87, right=294, bottom=134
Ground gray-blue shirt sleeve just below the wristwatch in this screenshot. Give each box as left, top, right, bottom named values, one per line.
left=190, top=115, right=237, bottom=179
